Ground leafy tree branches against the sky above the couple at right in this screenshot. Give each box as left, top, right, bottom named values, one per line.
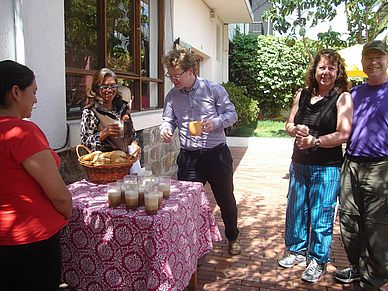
left=263, top=0, right=388, bottom=48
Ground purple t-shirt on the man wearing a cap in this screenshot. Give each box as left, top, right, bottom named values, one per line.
left=346, top=82, right=388, bottom=158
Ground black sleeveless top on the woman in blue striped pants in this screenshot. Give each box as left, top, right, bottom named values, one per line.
left=292, top=89, right=343, bottom=167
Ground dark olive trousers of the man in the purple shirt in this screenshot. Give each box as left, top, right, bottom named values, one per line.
left=339, top=156, right=388, bottom=290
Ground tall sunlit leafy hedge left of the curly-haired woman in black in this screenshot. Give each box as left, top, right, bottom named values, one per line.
left=229, top=34, right=316, bottom=117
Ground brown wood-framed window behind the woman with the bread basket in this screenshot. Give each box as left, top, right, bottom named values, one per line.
left=65, top=0, right=164, bottom=119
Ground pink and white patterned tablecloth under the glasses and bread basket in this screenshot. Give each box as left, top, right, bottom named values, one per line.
left=61, top=180, right=221, bottom=291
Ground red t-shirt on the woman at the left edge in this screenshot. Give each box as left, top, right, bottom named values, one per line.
left=0, top=116, right=67, bottom=245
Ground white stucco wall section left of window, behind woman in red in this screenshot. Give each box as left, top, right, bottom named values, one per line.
left=0, top=0, right=67, bottom=149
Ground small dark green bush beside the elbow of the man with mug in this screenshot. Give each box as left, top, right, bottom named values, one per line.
left=222, top=82, right=259, bottom=135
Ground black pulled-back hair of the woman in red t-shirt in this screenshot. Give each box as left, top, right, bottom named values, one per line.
left=0, top=60, right=35, bottom=106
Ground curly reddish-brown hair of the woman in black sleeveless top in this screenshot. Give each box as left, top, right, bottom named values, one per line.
left=305, top=49, right=349, bottom=95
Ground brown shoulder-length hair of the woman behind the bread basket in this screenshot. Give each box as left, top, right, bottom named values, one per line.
left=86, top=68, right=123, bottom=107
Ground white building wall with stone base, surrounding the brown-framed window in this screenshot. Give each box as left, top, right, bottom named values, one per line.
left=0, top=0, right=228, bottom=182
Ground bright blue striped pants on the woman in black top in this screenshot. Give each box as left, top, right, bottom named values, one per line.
left=285, top=163, right=340, bottom=263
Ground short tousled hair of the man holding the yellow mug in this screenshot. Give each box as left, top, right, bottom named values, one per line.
left=162, top=48, right=197, bottom=74
